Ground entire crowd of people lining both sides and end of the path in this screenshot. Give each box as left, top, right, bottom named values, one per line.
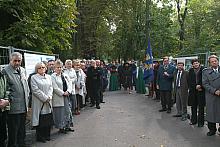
left=0, top=52, right=220, bottom=147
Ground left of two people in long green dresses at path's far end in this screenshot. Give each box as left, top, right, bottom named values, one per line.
left=109, top=61, right=119, bottom=91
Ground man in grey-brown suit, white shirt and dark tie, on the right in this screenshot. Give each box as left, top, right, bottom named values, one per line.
left=173, top=62, right=188, bottom=121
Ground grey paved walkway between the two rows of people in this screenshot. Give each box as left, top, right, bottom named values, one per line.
left=32, top=91, right=220, bottom=147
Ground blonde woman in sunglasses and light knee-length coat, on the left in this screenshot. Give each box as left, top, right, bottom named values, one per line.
left=31, top=62, right=53, bottom=142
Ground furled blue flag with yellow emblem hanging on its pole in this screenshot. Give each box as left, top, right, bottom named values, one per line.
left=144, top=38, right=154, bottom=84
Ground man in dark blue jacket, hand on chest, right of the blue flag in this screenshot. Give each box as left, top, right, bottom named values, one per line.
left=157, top=57, right=175, bottom=113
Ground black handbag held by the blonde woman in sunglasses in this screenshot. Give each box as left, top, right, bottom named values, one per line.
left=39, top=103, right=54, bottom=127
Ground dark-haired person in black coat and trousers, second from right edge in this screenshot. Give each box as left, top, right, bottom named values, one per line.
left=188, top=59, right=205, bottom=127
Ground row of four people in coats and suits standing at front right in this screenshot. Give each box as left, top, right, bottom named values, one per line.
left=156, top=55, right=220, bottom=136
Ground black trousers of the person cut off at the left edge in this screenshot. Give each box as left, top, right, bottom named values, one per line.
left=0, top=109, right=7, bottom=147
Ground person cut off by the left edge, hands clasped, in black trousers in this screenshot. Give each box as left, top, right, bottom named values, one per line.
left=0, top=67, right=9, bottom=147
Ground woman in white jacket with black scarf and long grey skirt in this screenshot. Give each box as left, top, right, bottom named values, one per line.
left=51, top=60, right=74, bottom=134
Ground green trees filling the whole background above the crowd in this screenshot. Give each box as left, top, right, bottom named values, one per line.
left=0, top=0, right=220, bottom=60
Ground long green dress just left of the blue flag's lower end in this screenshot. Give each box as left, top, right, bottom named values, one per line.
left=136, top=67, right=146, bottom=94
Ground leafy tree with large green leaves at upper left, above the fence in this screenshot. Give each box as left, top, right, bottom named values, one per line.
left=0, top=0, right=77, bottom=53
